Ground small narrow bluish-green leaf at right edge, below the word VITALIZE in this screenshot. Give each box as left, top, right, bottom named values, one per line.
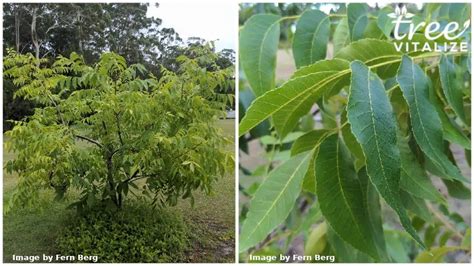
left=439, top=54, right=467, bottom=125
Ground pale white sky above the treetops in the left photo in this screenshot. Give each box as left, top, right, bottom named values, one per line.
left=147, top=1, right=238, bottom=51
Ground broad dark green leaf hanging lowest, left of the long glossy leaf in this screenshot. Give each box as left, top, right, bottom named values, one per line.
left=315, top=134, right=379, bottom=259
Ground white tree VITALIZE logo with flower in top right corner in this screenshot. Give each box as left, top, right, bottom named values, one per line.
left=388, top=6, right=471, bottom=52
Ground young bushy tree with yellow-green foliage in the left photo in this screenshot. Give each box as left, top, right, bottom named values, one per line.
left=4, top=50, right=233, bottom=211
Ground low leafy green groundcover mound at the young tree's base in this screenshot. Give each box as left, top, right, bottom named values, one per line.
left=57, top=205, right=189, bottom=263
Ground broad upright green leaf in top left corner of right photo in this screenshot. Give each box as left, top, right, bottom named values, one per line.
left=239, top=14, right=280, bottom=97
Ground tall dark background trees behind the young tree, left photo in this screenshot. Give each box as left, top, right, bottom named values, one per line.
left=3, top=3, right=234, bottom=129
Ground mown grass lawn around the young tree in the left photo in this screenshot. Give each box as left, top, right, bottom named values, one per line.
left=3, top=119, right=235, bottom=262
